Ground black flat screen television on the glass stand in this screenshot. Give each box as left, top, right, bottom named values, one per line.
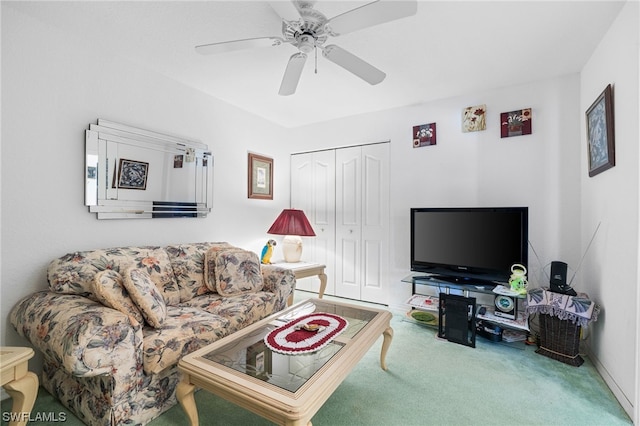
left=411, top=207, right=529, bottom=284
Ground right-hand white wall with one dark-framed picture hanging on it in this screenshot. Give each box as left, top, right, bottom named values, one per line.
left=580, top=2, right=640, bottom=424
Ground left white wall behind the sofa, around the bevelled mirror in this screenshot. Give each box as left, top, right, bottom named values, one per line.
left=0, top=7, right=289, bottom=352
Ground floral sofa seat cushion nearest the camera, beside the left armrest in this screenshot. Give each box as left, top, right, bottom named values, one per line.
left=142, top=306, right=229, bottom=374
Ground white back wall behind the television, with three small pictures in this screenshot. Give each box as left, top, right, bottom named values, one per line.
left=289, top=74, right=580, bottom=305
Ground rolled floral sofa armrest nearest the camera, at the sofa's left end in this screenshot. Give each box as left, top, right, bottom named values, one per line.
left=10, top=291, right=142, bottom=377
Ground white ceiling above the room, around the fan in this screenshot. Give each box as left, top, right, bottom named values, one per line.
left=3, top=0, right=624, bottom=127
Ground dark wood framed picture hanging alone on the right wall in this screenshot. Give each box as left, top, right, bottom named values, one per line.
left=585, top=84, right=616, bottom=177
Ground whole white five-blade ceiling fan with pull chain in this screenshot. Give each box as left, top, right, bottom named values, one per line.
left=196, top=0, right=418, bottom=96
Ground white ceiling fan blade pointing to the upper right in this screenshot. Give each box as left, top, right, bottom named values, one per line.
left=328, top=0, right=418, bottom=35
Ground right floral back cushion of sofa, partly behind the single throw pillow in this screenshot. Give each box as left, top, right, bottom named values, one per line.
left=166, top=242, right=233, bottom=305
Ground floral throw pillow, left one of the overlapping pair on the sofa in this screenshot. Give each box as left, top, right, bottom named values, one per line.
left=92, top=270, right=144, bottom=324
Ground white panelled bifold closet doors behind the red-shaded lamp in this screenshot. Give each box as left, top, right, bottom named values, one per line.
left=291, top=143, right=389, bottom=304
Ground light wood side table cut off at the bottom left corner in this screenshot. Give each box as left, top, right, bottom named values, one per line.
left=0, top=347, right=38, bottom=426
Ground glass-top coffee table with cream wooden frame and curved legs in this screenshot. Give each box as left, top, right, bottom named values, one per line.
left=177, top=299, right=393, bottom=425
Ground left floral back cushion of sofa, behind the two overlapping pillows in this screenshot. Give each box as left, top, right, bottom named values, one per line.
left=47, top=247, right=180, bottom=304
